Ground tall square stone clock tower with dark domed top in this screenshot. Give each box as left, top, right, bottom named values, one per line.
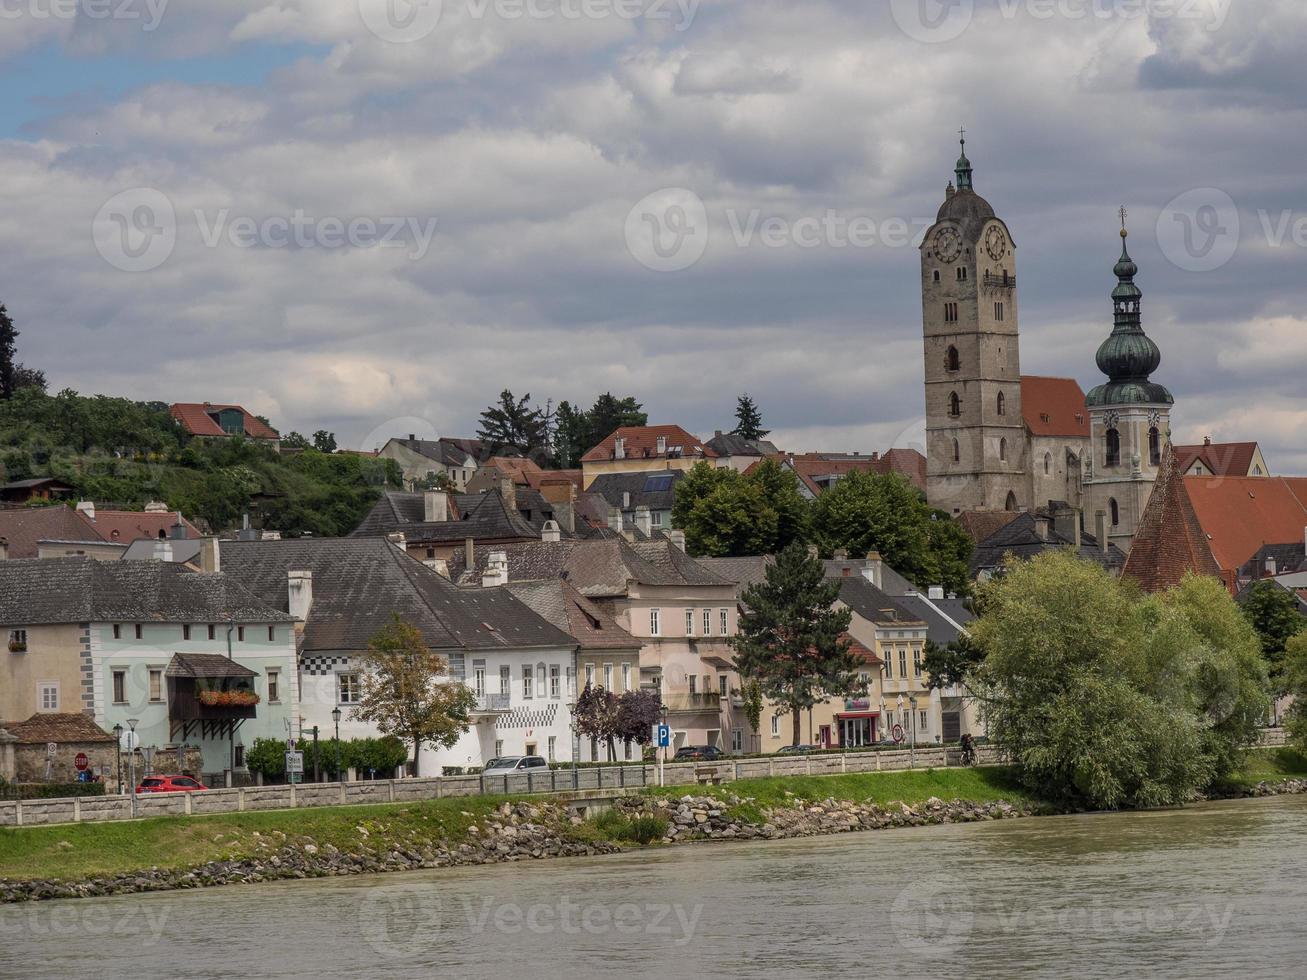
left=921, top=139, right=1034, bottom=514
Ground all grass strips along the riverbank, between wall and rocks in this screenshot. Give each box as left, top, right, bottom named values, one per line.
left=0, top=749, right=1307, bottom=882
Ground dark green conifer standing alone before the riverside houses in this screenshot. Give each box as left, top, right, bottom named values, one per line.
left=731, top=544, right=864, bottom=745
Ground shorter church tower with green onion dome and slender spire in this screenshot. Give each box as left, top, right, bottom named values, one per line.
left=1084, top=214, right=1175, bottom=551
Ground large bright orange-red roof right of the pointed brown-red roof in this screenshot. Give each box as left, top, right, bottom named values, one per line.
left=1184, top=476, right=1307, bottom=570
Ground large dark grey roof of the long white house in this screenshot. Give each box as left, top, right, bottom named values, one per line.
left=222, top=538, right=572, bottom=661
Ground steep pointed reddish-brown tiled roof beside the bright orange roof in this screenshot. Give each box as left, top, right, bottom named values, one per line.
left=1121, top=446, right=1221, bottom=592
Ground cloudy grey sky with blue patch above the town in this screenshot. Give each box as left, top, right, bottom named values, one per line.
left=0, top=0, right=1307, bottom=473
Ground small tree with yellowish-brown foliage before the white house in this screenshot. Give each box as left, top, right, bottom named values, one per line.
left=350, top=615, right=477, bottom=775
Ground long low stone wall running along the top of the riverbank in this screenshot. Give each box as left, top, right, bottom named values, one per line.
left=0, top=746, right=999, bottom=827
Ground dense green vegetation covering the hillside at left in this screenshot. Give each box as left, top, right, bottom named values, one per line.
left=0, top=389, right=401, bottom=537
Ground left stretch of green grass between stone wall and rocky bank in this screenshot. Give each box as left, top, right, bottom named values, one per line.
left=0, top=797, right=517, bottom=881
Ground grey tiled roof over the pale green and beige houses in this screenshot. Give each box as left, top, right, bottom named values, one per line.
left=0, top=556, right=291, bottom=626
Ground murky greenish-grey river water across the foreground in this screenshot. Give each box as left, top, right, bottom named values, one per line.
left=0, top=797, right=1307, bottom=980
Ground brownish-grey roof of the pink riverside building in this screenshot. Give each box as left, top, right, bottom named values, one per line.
left=450, top=536, right=732, bottom=597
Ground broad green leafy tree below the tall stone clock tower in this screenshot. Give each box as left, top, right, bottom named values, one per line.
left=812, top=470, right=972, bottom=592
